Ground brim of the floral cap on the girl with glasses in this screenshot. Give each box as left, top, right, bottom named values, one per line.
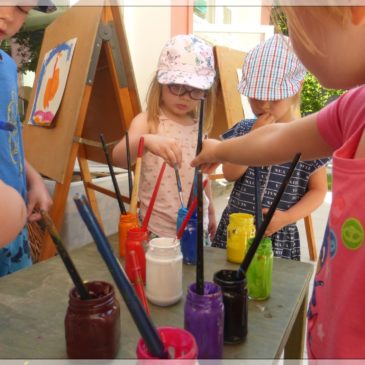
left=157, top=70, right=215, bottom=90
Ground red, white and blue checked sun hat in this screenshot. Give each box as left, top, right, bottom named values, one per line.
left=238, top=34, right=306, bottom=100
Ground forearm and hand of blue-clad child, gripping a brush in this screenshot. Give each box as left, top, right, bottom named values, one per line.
left=25, top=161, right=53, bottom=222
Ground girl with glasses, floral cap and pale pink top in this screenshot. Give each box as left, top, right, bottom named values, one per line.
left=113, top=34, right=216, bottom=237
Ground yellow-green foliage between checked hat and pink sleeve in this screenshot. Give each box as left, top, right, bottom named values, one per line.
left=300, top=72, right=344, bottom=115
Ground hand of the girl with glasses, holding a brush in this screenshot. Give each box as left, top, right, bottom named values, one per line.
left=143, top=134, right=182, bottom=168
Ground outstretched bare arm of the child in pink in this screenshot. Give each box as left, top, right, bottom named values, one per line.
left=191, top=113, right=334, bottom=172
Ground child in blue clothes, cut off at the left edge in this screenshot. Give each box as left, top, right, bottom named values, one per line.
left=0, top=6, right=52, bottom=276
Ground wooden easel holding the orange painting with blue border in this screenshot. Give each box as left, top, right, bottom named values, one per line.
left=24, top=5, right=141, bottom=260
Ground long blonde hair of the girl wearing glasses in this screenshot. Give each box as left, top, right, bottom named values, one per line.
left=147, top=71, right=216, bottom=134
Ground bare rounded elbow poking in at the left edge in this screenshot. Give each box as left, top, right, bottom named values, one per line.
left=0, top=180, right=27, bottom=247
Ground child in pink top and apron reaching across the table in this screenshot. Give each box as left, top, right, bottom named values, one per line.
left=192, top=6, right=365, bottom=359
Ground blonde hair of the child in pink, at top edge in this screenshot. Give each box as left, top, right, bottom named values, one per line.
left=272, top=6, right=351, bottom=54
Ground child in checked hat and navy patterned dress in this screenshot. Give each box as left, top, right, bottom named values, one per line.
left=212, top=34, right=328, bottom=260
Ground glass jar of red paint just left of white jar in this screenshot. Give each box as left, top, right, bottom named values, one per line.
left=125, top=227, right=148, bottom=284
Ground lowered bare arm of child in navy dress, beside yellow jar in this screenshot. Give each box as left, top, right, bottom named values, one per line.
left=263, top=166, right=328, bottom=236
